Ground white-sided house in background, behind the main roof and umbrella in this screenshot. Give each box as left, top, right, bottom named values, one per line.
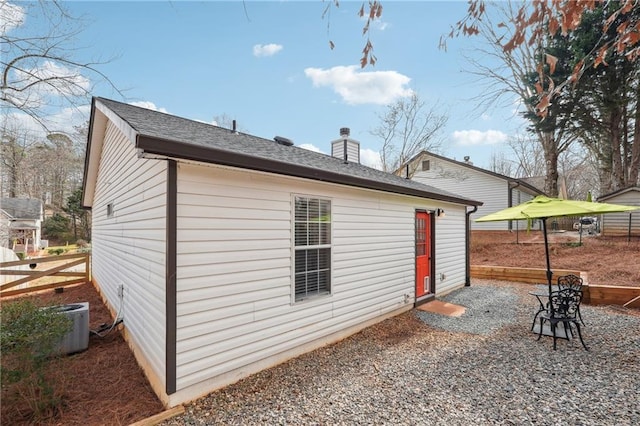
left=396, top=151, right=543, bottom=231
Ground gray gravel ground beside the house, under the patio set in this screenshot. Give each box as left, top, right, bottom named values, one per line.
left=164, top=280, right=640, bottom=426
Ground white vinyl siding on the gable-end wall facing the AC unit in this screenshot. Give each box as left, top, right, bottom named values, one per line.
left=92, top=121, right=167, bottom=380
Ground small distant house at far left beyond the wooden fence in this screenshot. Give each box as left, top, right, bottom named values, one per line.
left=0, top=198, right=44, bottom=253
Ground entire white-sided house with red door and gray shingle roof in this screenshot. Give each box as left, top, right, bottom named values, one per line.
left=83, top=98, right=481, bottom=406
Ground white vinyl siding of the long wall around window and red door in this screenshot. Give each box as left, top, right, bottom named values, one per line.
left=172, top=163, right=465, bottom=399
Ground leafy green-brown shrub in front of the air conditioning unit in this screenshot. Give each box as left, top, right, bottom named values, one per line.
left=0, top=299, right=72, bottom=421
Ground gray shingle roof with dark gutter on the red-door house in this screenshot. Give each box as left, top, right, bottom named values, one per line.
left=94, top=98, right=482, bottom=205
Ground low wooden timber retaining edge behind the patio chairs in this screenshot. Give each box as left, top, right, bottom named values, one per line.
left=471, top=265, right=640, bottom=308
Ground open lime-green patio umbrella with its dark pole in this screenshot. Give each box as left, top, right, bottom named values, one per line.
left=476, top=195, right=640, bottom=292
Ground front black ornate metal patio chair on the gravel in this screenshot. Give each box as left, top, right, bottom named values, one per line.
left=538, top=288, right=589, bottom=351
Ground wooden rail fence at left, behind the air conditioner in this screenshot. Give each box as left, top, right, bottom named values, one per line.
left=0, top=253, right=91, bottom=297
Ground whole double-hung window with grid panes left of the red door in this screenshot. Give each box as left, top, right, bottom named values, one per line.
left=294, top=196, right=331, bottom=302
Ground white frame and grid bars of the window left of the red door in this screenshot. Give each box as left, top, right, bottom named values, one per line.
left=291, top=194, right=333, bottom=304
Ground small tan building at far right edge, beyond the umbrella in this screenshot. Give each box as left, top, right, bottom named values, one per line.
left=597, top=186, right=640, bottom=237
